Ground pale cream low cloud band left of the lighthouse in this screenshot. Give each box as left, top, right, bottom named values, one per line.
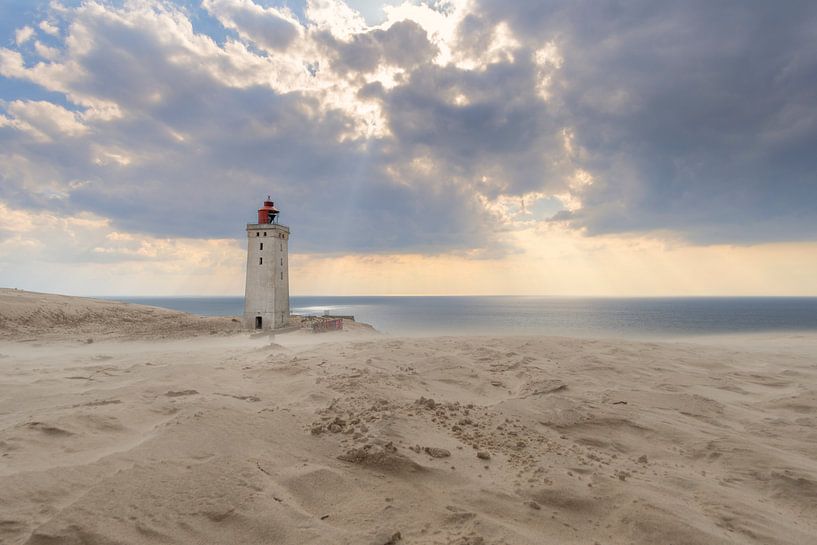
left=0, top=203, right=245, bottom=295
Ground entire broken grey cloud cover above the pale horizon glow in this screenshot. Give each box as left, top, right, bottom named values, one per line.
left=0, top=0, right=817, bottom=266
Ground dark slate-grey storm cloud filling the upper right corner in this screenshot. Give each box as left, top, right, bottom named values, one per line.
left=480, top=0, right=817, bottom=242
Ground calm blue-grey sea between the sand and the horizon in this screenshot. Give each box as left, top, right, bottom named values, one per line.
left=106, top=296, right=817, bottom=339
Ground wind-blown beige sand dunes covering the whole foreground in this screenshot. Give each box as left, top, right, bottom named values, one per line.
left=0, top=295, right=817, bottom=545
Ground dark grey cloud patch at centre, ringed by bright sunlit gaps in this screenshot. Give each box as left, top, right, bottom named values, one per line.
left=382, top=55, right=566, bottom=198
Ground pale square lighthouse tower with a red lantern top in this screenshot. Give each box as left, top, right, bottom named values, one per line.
left=244, top=197, right=289, bottom=329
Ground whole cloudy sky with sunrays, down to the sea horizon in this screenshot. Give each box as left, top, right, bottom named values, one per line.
left=0, top=0, right=817, bottom=296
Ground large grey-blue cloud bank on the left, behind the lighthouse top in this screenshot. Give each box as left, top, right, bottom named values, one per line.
left=0, top=2, right=556, bottom=252
